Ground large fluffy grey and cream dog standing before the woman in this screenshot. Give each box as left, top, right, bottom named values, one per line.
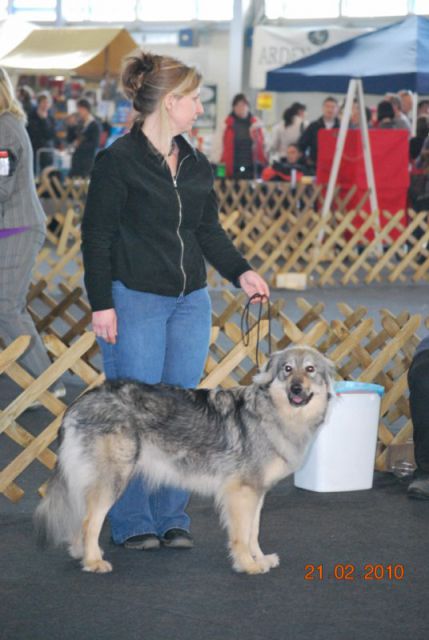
left=35, top=346, right=334, bottom=574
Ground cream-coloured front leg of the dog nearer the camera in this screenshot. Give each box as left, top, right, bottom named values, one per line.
left=222, top=482, right=270, bottom=574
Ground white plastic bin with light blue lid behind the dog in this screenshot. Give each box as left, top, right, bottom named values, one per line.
left=295, top=381, right=384, bottom=491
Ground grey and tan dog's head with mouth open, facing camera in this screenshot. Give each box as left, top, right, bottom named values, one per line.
left=254, top=346, right=335, bottom=407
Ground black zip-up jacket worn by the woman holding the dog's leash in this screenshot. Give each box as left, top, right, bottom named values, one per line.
left=82, top=127, right=251, bottom=311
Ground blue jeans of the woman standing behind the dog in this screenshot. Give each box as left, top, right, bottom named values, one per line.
left=99, top=281, right=211, bottom=544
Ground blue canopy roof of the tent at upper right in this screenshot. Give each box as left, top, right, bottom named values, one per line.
left=266, top=16, right=429, bottom=94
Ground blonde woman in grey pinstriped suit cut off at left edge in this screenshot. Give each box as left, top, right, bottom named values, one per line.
left=0, top=68, right=61, bottom=388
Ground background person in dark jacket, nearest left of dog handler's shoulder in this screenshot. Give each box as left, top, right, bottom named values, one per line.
left=70, top=98, right=100, bottom=178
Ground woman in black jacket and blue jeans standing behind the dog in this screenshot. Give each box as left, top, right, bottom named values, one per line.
left=82, top=52, right=269, bottom=550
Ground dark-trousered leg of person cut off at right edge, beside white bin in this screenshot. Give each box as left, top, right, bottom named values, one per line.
left=408, top=336, right=429, bottom=500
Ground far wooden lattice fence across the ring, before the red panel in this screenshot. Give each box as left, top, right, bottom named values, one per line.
left=35, top=176, right=429, bottom=290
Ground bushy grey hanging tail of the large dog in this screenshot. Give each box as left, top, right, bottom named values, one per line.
left=33, top=428, right=85, bottom=547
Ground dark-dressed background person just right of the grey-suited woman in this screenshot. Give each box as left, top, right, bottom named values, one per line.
left=27, top=93, right=56, bottom=174
